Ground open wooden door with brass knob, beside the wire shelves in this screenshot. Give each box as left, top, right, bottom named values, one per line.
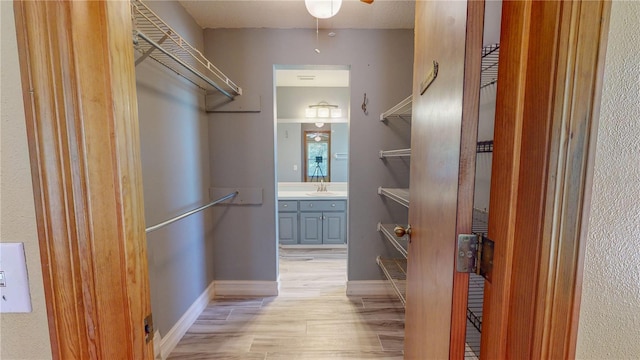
left=405, top=1, right=484, bottom=360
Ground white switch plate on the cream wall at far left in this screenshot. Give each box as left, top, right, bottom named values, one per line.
left=0, top=243, right=31, bottom=313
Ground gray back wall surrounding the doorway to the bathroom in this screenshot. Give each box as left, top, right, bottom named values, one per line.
left=205, top=29, right=413, bottom=280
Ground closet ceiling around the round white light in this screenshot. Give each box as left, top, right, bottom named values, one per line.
left=179, top=0, right=415, bottom=29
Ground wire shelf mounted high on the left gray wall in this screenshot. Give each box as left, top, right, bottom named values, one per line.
left=131, top=0, right=242, bottom=99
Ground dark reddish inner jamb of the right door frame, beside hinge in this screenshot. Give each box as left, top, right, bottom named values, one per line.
left=480, top=1, right=532, bottom=359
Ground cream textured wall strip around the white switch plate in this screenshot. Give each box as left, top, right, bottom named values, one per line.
left=0, top=1, right=51, bottom=360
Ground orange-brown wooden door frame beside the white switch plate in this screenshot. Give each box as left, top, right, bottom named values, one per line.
left=14, top=1, right=153, bottom=359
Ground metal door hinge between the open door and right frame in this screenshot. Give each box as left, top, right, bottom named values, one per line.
left=456, top=234, right=493, bottom=282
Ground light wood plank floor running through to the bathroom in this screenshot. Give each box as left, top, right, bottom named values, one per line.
left=169, top=250, right=404, bottom=360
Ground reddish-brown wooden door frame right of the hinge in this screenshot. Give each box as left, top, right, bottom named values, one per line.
left=481, top=1, right=611, bottom=359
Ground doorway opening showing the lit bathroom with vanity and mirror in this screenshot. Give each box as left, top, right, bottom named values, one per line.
left=274, top=65, right=350, bottom=283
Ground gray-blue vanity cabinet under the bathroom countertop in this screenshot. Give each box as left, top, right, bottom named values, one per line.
left=278, top=200, right=347, bottom=245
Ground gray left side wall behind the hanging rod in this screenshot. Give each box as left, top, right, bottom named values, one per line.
left=136, top=1, right=213, bottom=336
